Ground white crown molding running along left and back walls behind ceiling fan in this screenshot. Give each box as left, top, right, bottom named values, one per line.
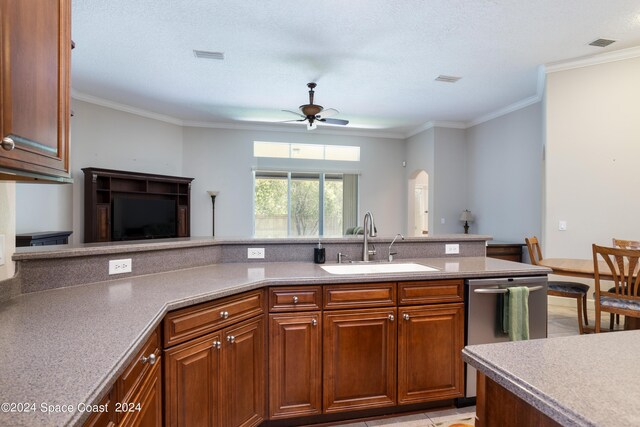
left=71, top=89, right=405, bottom=139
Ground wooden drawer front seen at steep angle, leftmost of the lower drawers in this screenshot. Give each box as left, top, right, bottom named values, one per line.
left=116, top=328, right=160, bottom=412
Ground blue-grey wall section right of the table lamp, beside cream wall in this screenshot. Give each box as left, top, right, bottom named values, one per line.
left=467, top=102, right=543, bottom=242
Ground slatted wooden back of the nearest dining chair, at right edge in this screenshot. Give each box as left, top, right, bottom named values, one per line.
left=593, top=244, right=640, bottom=304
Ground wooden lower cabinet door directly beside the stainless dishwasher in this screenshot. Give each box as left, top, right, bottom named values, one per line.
left=398, top=304, right=464, bottom=404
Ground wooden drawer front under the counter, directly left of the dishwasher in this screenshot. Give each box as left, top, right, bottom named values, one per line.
left=398, top=280, right=464, bottom=305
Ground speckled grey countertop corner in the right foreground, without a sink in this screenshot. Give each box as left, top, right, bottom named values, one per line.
left=462, top=331, right=640, bottom=426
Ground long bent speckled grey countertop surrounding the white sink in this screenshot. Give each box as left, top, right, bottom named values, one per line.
left=0, top=257, right=550, bottom=426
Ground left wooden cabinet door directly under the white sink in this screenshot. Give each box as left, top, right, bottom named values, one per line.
left=323, top=308, right=397, bottom=413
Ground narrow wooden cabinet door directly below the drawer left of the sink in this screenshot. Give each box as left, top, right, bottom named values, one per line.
left=269, top=312, right=322, bottom=419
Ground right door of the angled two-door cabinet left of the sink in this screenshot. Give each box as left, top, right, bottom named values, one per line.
left=220, top=316, right=267, bottom=427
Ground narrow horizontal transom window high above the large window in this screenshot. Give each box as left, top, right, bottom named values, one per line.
left=253, top=141, right=360, bottom=162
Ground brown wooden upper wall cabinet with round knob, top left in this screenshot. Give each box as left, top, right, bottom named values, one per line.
left=0, top=0, right=71, bottom=182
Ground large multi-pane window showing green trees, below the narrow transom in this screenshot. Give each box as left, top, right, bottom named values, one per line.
left=254, top=171, right=358, bottom=237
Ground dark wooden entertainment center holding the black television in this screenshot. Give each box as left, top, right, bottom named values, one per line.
left=82, top=168, right=193, bottom=243
